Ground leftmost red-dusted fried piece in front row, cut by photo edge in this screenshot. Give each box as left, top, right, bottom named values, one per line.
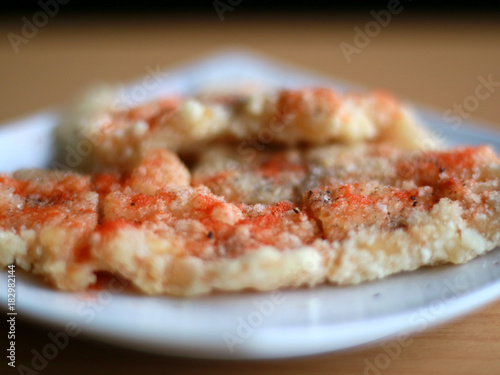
left=0, top=170, right=98, bottom=290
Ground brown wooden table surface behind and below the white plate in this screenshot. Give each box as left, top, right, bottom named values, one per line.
left=0, top=13, right=500, bottom=375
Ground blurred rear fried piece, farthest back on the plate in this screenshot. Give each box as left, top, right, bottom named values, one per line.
left=56, top=88, right=429, bottom=171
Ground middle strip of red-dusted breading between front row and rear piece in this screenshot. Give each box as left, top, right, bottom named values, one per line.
left=192, top=143, right=497, bottom=204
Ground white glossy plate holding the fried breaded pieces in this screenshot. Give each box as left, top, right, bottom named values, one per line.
left=0, top=53, right=500, bottom=359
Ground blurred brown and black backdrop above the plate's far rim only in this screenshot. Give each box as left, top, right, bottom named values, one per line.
left=0, top=0, right=500, bottom=122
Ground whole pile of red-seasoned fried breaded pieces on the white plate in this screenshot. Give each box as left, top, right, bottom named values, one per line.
left=0, top=88, right=500, bottom=296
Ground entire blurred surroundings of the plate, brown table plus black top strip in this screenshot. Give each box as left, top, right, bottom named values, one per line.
left=0, top=0, right=500, bottom=374
